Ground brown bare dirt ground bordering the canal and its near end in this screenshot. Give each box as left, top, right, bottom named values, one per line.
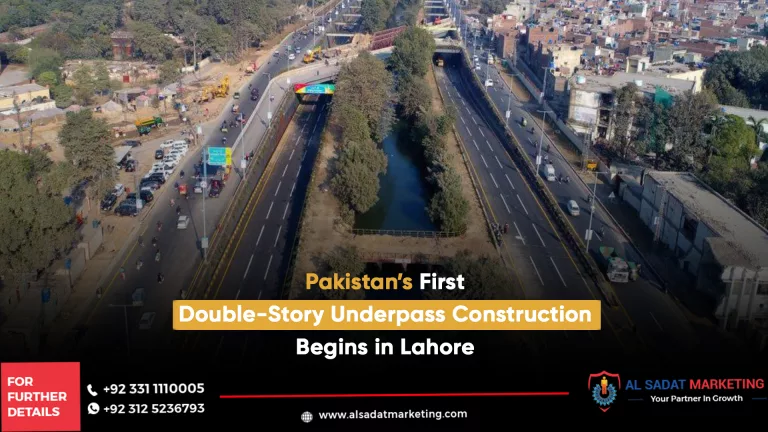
left=290, top=66, right=495, bottom=298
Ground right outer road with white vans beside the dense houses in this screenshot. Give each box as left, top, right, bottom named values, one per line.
left=462, top=44, right=698, bottom=352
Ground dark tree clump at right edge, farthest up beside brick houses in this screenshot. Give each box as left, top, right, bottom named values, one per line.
left=704, top=45, right=768, bottom=108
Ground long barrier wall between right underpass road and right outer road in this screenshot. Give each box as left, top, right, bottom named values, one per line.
left=460, top=48, right=619, bottom=307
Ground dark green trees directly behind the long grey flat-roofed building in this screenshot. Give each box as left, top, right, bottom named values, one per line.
left=609, top=83, right=768, bottom=225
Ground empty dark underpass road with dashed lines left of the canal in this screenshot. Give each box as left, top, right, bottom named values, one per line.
left=192, top=96, right=330, bottom=360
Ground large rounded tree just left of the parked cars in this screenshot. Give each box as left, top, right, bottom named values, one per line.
left=59, top=110, right=115, bottom=196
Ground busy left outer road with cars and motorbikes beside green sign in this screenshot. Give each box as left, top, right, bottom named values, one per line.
left=72, top=37, right=338, bottom=354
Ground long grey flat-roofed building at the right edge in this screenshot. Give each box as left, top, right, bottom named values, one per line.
left=640, top=171, right=768, bottom=328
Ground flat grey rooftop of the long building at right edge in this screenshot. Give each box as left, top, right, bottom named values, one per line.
left=648, top=171, right=768, bottom=268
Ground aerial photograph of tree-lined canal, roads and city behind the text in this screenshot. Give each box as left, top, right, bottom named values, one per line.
left=0, top=0, right=768, bottom=384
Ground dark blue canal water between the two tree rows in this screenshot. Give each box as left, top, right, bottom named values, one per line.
left=355, top=122, right=437, bottom=231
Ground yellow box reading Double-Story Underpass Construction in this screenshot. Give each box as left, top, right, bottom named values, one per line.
left=173, top=300, right=600, bottom=330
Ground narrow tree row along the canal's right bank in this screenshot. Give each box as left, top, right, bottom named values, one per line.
left=389, top=27, right=469, bottom=232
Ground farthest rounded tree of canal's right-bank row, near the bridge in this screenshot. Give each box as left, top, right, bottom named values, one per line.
left=389, top=27, right=435, bottom=78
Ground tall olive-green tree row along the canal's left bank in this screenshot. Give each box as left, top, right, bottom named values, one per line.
left=331, top=52, right=392, bottom=218
